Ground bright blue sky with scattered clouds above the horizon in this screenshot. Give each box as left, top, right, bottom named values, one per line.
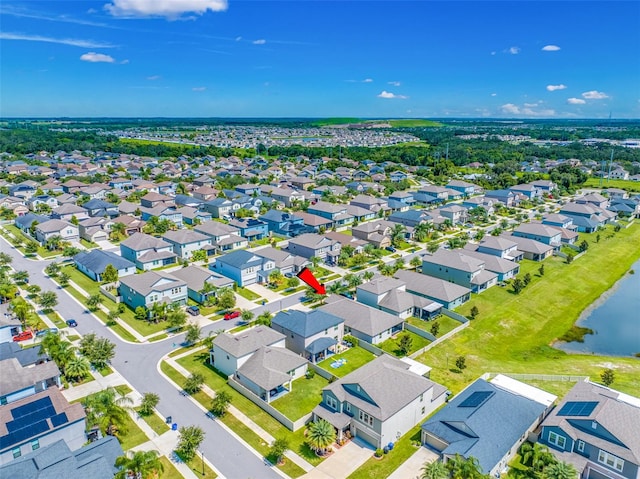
left=0, top=0, right=640, bottom=118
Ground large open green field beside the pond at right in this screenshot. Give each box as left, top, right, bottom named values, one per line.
left=418, top=224, right=640, bottom=394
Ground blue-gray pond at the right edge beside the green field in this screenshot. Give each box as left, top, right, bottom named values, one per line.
left=557, top=260, right=640, bottom=356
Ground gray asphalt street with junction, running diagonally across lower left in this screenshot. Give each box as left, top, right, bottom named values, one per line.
left=0, top=238, right=282, bottom=479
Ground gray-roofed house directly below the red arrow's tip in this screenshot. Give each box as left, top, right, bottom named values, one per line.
left=317, top=295, right=404, bottom=344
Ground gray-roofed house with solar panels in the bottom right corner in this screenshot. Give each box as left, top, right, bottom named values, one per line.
left=538, top=381, right=640, bottom=479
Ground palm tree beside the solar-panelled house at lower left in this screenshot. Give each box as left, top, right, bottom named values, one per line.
left=82, top=387, right=133, bottom=436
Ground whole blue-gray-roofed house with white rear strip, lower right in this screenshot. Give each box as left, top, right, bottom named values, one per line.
left=422, top=375, right=556, bottom=477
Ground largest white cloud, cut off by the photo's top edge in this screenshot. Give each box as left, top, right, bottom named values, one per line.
left=104, top=0, right=227, bottom=20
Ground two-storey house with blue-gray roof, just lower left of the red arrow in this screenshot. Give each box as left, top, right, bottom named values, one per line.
left=271, top=309, right=344, bottom=363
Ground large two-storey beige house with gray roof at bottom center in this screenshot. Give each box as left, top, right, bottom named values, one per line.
left=313, top=354, right=447, bottom=448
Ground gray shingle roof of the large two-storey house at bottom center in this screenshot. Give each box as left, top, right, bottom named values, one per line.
left=324, top=354, right=446, bottom=421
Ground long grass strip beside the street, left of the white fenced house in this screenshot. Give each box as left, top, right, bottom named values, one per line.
left=171, top=351, right=322, bottom=465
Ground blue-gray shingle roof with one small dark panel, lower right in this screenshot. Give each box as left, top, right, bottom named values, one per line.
left=422, top=379, right=546, bottom=474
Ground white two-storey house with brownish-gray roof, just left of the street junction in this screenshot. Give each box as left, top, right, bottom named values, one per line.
left=118, top=271, right=188, bottom=310
